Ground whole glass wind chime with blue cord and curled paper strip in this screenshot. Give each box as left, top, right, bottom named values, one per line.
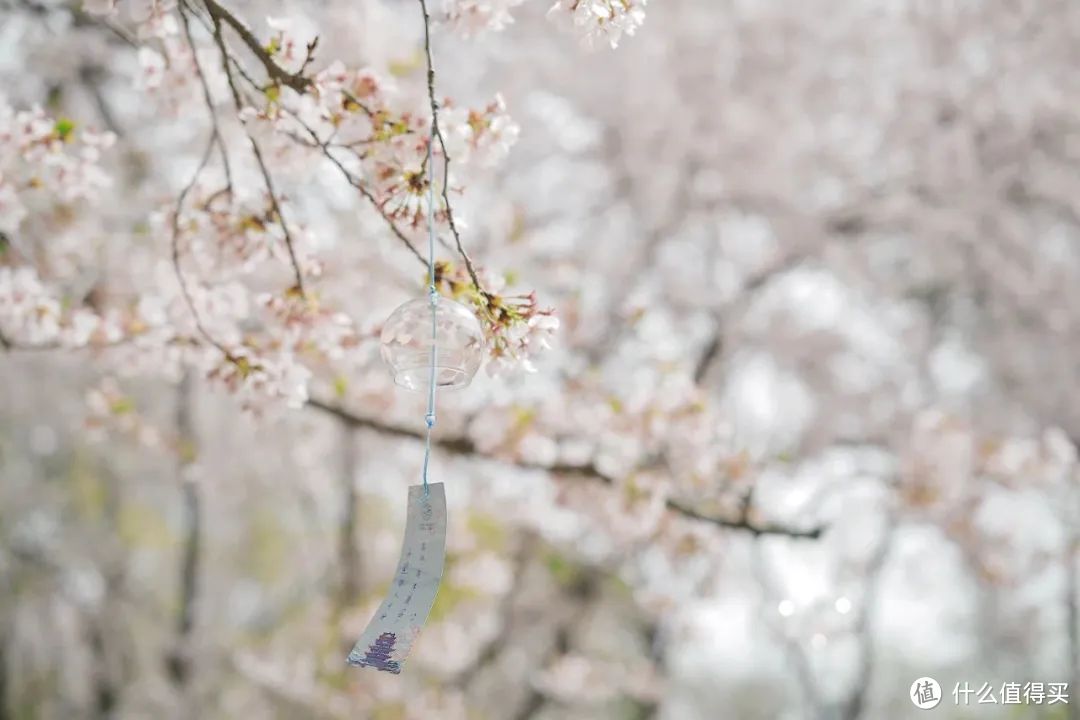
left=348, top=117, right=484, bottom=674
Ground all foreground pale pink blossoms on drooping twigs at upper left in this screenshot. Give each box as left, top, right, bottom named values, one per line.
left=0, top=0, right=558, bottom=410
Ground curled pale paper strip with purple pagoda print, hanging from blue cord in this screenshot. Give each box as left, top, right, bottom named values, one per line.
left=348, top=483, right=446, bottom=674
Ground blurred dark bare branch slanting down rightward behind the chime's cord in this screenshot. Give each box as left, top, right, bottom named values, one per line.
left=308, top=398, right=825, bottom=540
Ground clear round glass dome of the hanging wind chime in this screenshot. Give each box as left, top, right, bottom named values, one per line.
left=379, top=297, right=484, bottom=391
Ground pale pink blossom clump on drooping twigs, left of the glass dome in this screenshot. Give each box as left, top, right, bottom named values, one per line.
left=158, top=183, right=356, bottom=410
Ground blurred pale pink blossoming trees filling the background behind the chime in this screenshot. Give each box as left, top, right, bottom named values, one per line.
left=0, top=0, right=1080, bottom=720
